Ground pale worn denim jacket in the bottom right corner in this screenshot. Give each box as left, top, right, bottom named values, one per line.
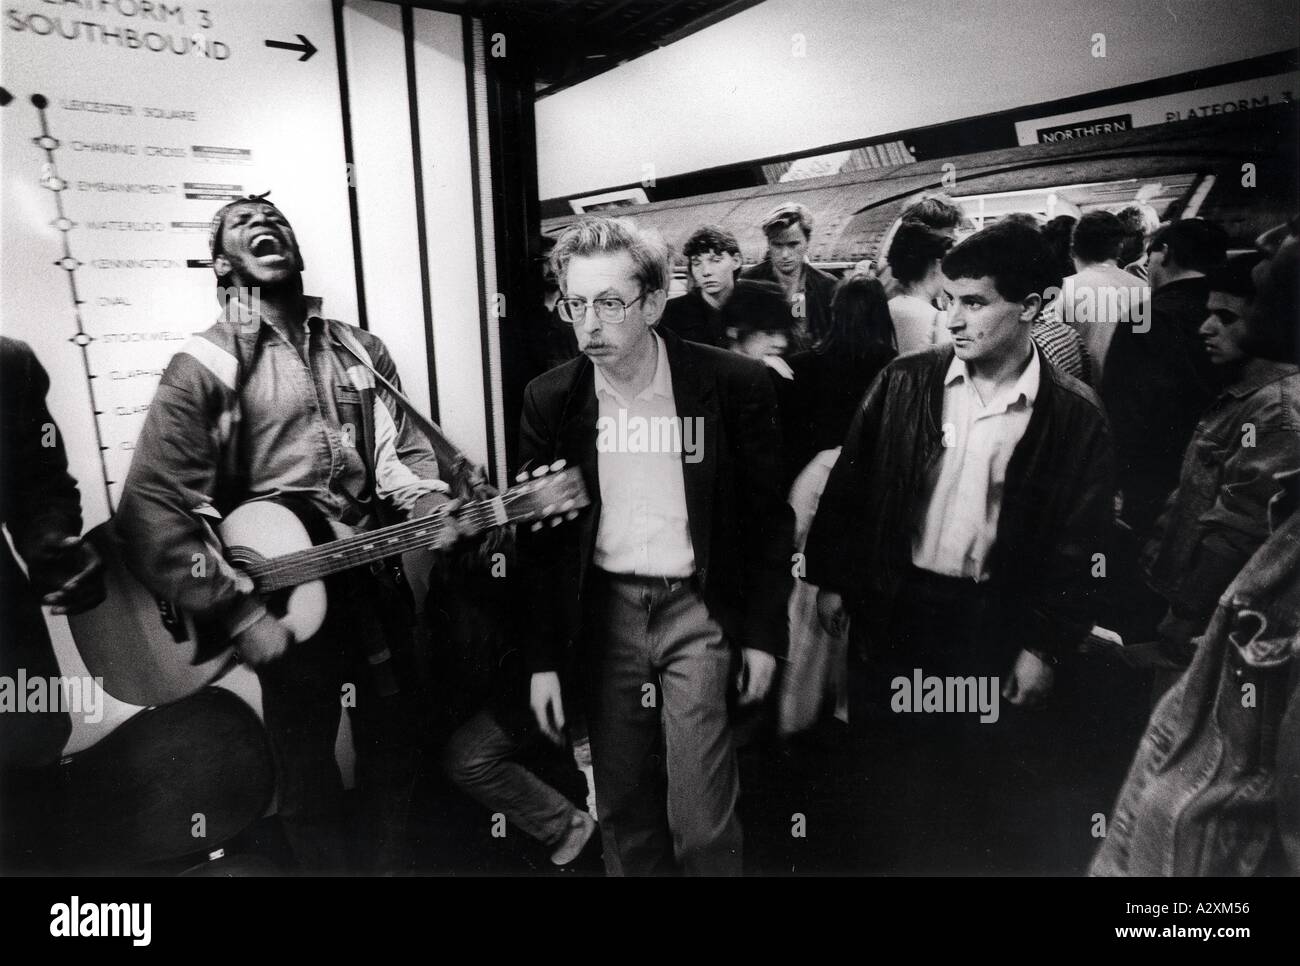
left=1089, top=468, right=1300, bottom=876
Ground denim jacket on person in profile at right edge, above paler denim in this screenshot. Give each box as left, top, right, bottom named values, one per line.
left=1144, top=359, right=1300, bottom=641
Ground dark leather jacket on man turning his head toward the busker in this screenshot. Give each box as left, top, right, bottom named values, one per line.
left=805, top=346, right=1114, bottom=657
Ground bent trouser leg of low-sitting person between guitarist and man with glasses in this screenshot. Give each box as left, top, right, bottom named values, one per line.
left=442, top=709, right=577, bottom=845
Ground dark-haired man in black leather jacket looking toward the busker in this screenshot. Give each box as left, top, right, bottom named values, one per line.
left=806, top=224, right=1113, bottom=871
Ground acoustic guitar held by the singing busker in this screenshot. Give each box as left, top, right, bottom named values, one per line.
left=68, top=467, right=590, bottom=706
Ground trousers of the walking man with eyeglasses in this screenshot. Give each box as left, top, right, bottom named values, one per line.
left=588, top=571, right=741, bottom=875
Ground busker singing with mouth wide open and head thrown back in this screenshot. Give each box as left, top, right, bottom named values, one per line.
left=117, top=196, right=480, bottom=871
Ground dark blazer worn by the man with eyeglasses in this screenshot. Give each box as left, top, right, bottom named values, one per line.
left=517, top=325, right=794, bottom=672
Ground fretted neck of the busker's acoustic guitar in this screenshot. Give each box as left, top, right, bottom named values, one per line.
left=244, top=497, right=511, bottom=593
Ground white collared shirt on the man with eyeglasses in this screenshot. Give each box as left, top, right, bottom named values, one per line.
left=593, top=333, right=696, bottom=577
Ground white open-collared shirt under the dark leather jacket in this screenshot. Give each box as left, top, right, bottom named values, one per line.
left=911, top=348, right=1041, bottom=581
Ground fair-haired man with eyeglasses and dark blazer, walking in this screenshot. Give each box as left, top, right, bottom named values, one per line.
left=519, top=218, right=793, bottom=875
